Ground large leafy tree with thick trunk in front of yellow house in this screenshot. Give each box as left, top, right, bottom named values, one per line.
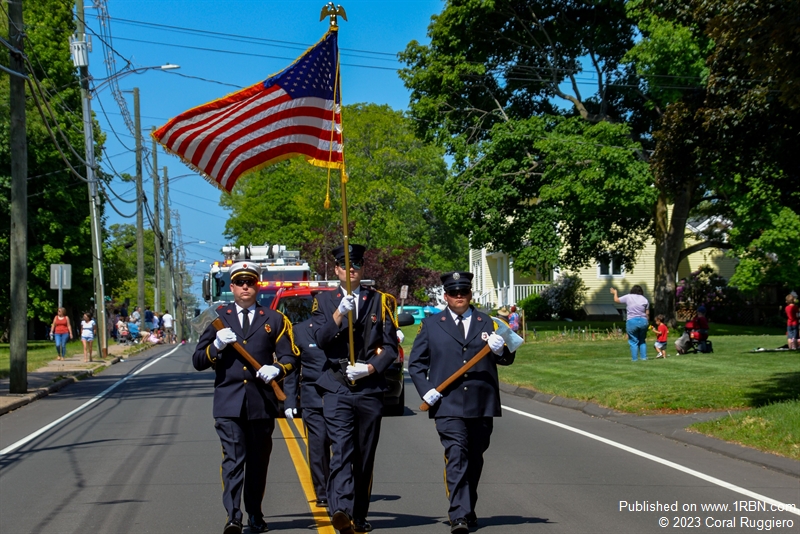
left=401, top=0, right=796, bottom=316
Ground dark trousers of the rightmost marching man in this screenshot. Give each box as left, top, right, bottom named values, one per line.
left=434, top=417, right=494, bottom=521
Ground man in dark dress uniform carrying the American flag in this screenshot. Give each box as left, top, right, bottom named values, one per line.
left=312, top=245, right=397, bottom=534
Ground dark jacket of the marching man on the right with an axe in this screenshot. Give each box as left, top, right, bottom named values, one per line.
left=408, top=307, right=515, bottom=417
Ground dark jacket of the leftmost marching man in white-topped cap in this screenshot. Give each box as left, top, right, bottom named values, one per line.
left=192, top=304, right=298, bottom=419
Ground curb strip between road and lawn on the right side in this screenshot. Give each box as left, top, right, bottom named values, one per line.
left=500, top=382, right=800, bottom=477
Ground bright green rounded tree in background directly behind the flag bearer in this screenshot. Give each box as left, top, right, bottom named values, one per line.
left=220, top=104, right=467, bottom=270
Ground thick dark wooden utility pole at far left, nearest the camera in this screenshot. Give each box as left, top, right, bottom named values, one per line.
left=7, top=0, right=28, bottom=393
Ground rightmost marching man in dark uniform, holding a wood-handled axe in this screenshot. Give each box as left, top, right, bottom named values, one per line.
left=408, top=272, right=515, bottom=534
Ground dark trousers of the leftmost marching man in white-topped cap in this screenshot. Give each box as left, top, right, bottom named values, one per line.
left=214, top=417, right=275, bottom=521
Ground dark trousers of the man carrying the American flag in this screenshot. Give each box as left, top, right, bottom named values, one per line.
left=322, top=393, right=383, bottom=519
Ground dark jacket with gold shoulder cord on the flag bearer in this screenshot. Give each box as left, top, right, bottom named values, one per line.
left=311, top=286, right=397, bottom=394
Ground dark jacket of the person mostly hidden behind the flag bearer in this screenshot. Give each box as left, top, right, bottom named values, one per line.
left=283, top=320, right=330, bottom=408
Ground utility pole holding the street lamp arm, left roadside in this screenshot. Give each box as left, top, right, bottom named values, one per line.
left=71, top=0, right=108, bottom=357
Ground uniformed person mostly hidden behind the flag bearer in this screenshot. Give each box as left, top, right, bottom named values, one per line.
left=283, top=319, right=331, bottom=507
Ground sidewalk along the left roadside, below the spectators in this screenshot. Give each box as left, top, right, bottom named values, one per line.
left=0, top=344, right=130, bottom=415
